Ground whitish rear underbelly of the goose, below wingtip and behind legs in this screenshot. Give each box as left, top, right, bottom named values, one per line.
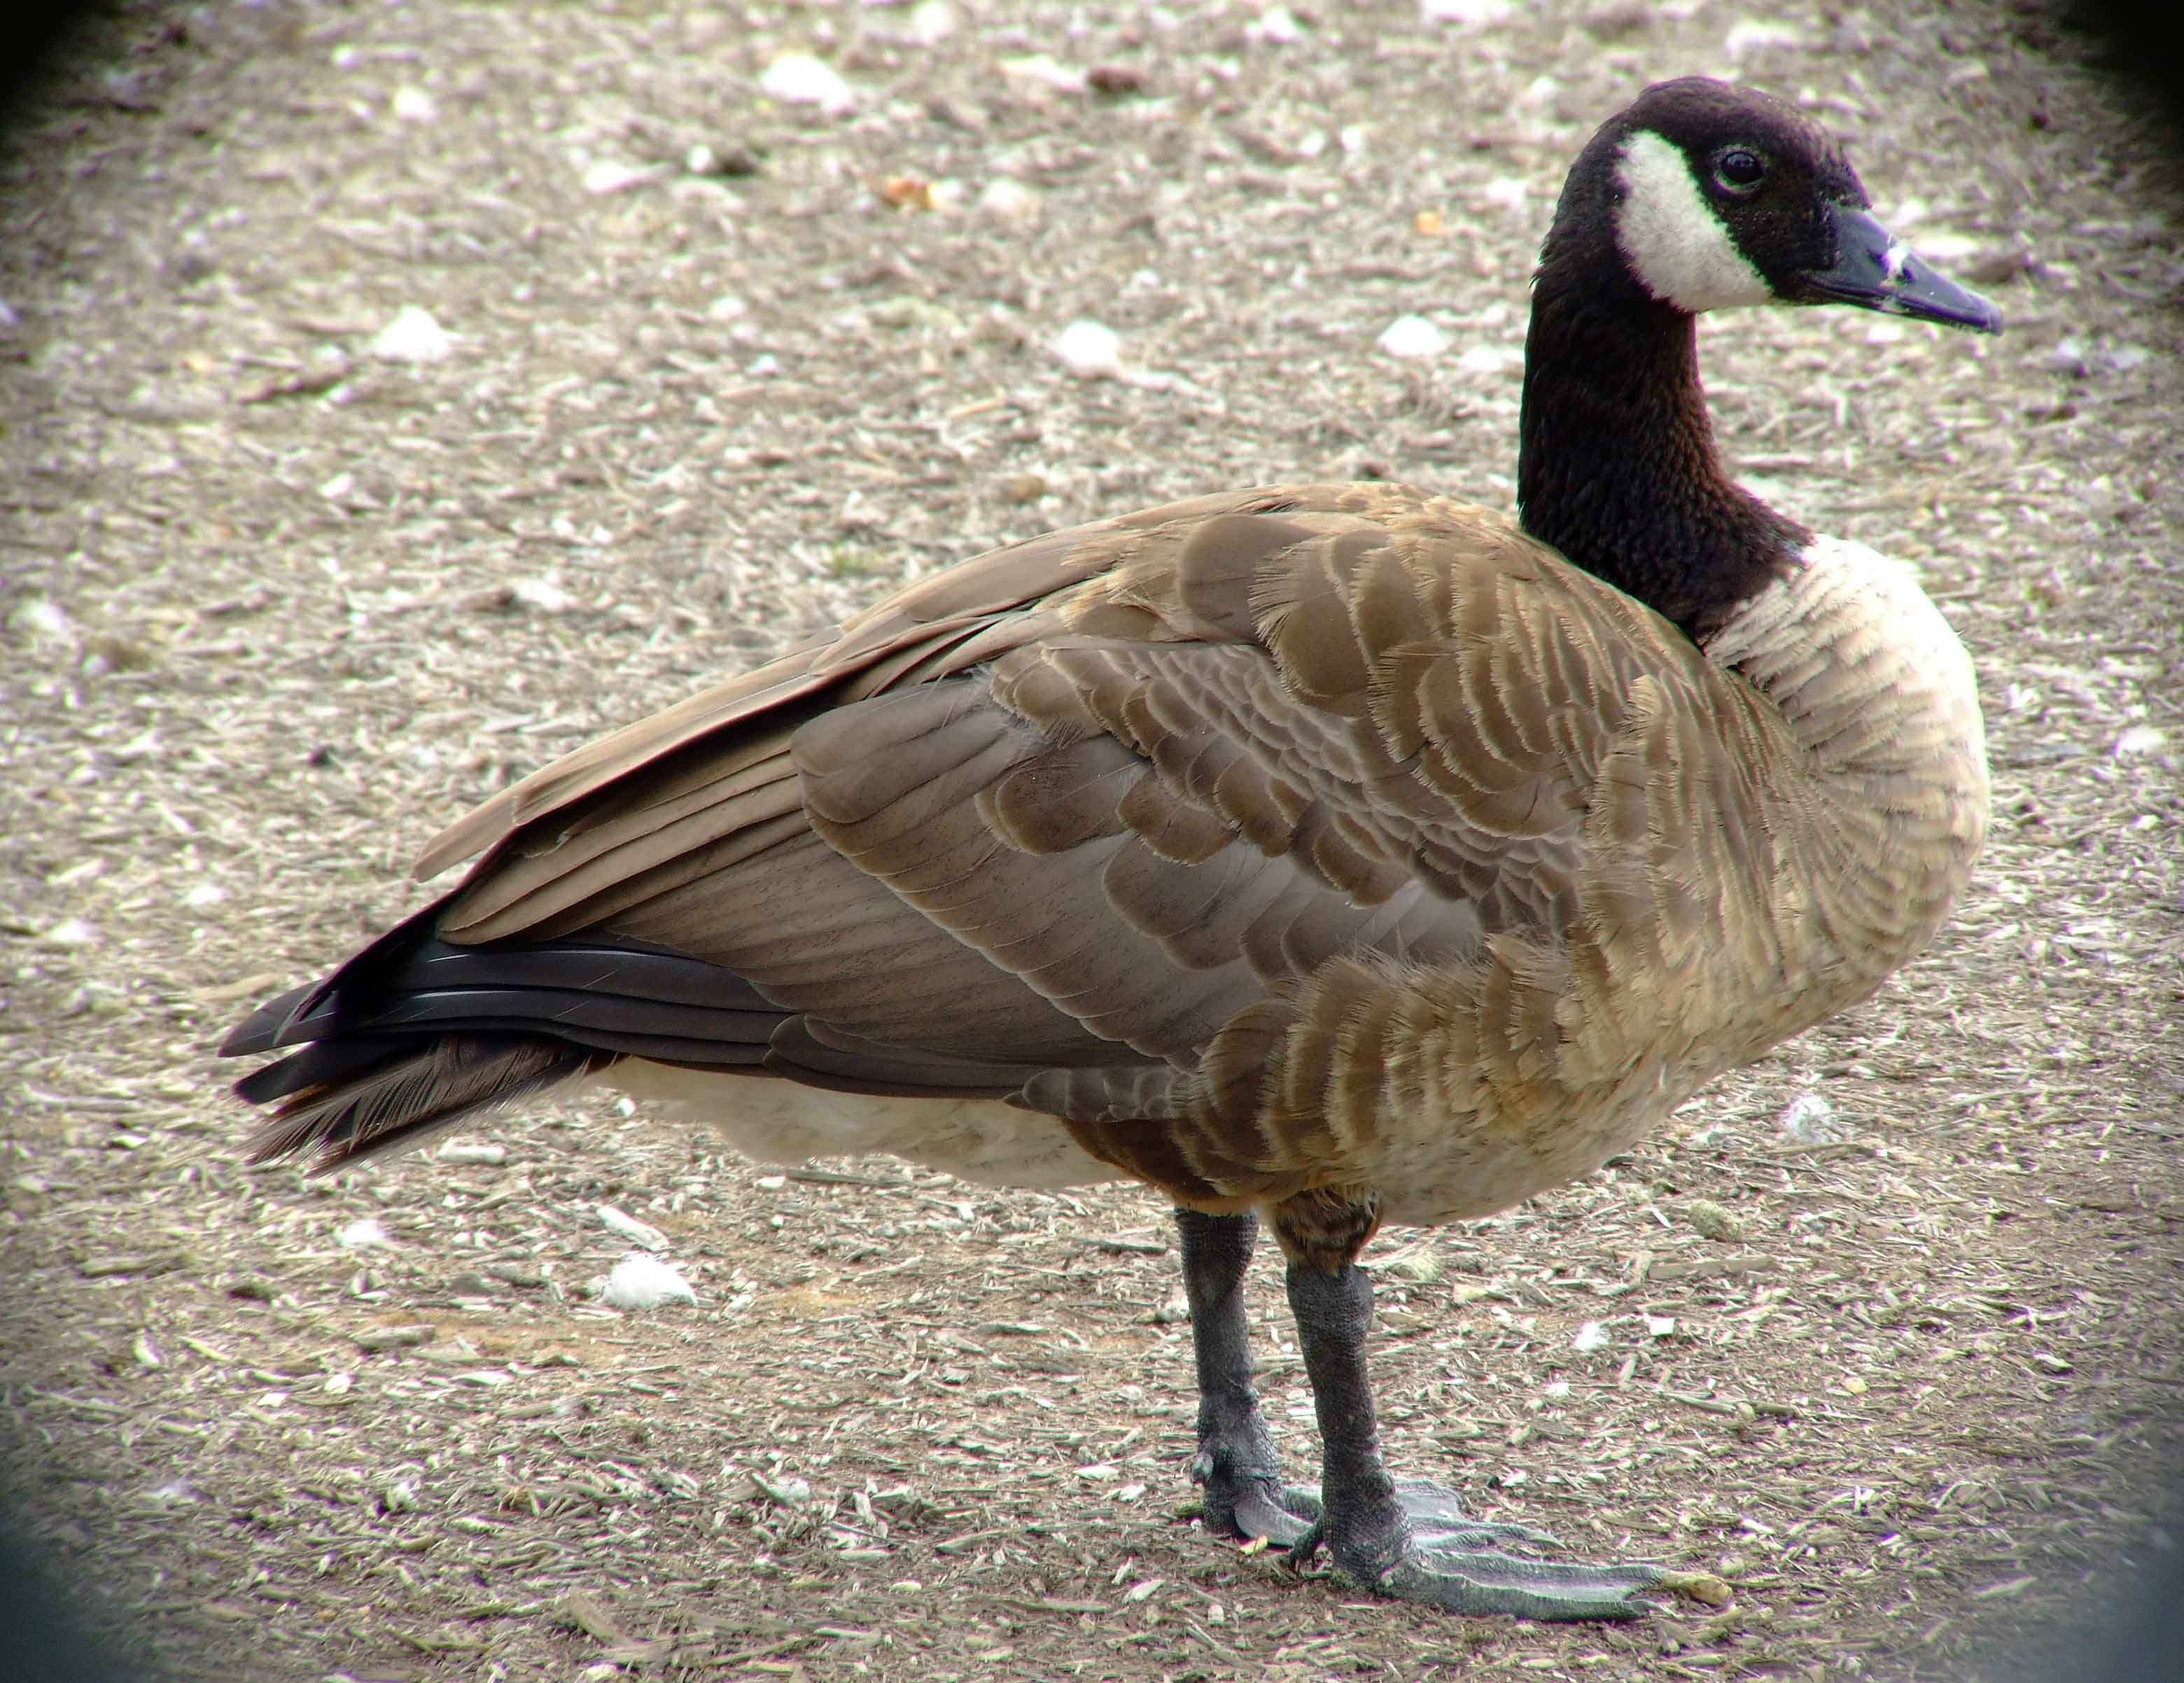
left=594, top=1059, right=1121, bottom=1189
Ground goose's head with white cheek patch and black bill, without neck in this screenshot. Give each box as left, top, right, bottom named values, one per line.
left=1558, top=76, right=2003, bottom=334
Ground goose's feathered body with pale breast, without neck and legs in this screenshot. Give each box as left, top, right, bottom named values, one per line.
left=238, top=484, right=1987, bottom=1234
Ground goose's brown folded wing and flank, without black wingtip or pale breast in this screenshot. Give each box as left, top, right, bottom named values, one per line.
left=402, top=487, right=1780, bottom=1203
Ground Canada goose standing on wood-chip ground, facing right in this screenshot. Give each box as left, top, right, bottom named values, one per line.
left=223, top=78, right=2001, bottom=1617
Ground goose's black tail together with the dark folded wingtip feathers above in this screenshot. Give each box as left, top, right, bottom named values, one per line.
left=220, top=910, right=786, bottom=1172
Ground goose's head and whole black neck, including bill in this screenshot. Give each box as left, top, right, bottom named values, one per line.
left=1518, top=76, right=2003, bottom=644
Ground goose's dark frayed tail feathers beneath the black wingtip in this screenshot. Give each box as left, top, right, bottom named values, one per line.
left=236, top=1035, right=614, bottom=1174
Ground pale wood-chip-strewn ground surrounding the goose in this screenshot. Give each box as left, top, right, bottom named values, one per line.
left=0, top=0, right=2184, bottom=1683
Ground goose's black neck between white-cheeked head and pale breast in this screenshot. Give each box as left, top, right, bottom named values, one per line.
left=1516, top=227, right=1813, bottom=642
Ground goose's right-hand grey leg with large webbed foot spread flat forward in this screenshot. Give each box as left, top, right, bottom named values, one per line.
left=1289, top=1262, right=1728, bottom=1620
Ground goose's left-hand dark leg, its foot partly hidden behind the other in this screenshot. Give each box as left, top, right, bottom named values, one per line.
left=1175, top=1209, right=1319, bottom=1548
